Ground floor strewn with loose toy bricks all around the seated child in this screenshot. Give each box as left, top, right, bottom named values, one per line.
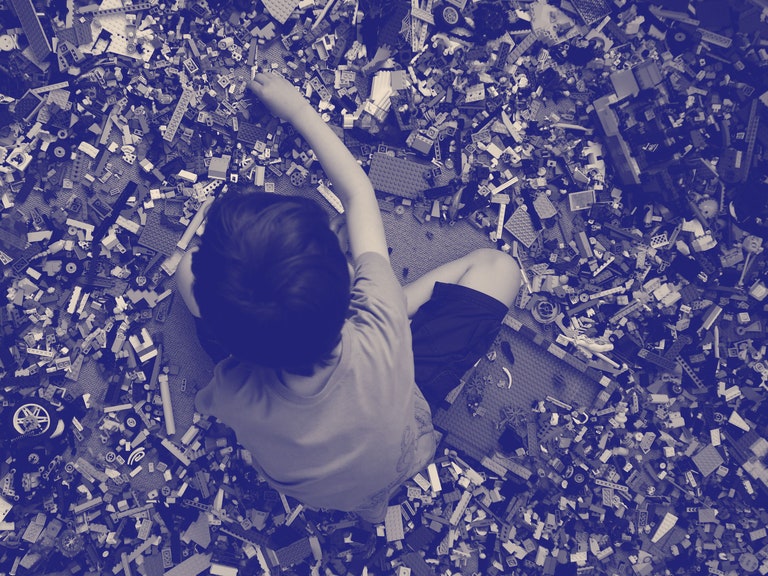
left=0, top=0, right=768, bottom=576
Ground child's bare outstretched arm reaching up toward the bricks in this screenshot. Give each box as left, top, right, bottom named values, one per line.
left=249, top=73, right=389, bottom=260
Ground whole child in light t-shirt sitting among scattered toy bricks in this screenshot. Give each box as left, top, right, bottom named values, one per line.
left=176, top=74, right=520, bottom=522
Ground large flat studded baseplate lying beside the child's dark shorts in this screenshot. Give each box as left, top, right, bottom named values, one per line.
left=433, top=318, right=602, bottom=461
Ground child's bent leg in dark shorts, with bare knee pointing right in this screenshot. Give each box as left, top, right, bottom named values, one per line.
left=405, top=250, right=521, bottom=411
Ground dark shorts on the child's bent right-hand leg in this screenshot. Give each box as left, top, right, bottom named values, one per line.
left=411, top=282, right=508, bottom=411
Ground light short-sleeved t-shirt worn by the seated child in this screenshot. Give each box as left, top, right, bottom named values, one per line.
left=195, top=252, right=435, bottom=522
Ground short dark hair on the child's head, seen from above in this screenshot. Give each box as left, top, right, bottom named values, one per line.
left=192, top=191, right=350, bottom=375
